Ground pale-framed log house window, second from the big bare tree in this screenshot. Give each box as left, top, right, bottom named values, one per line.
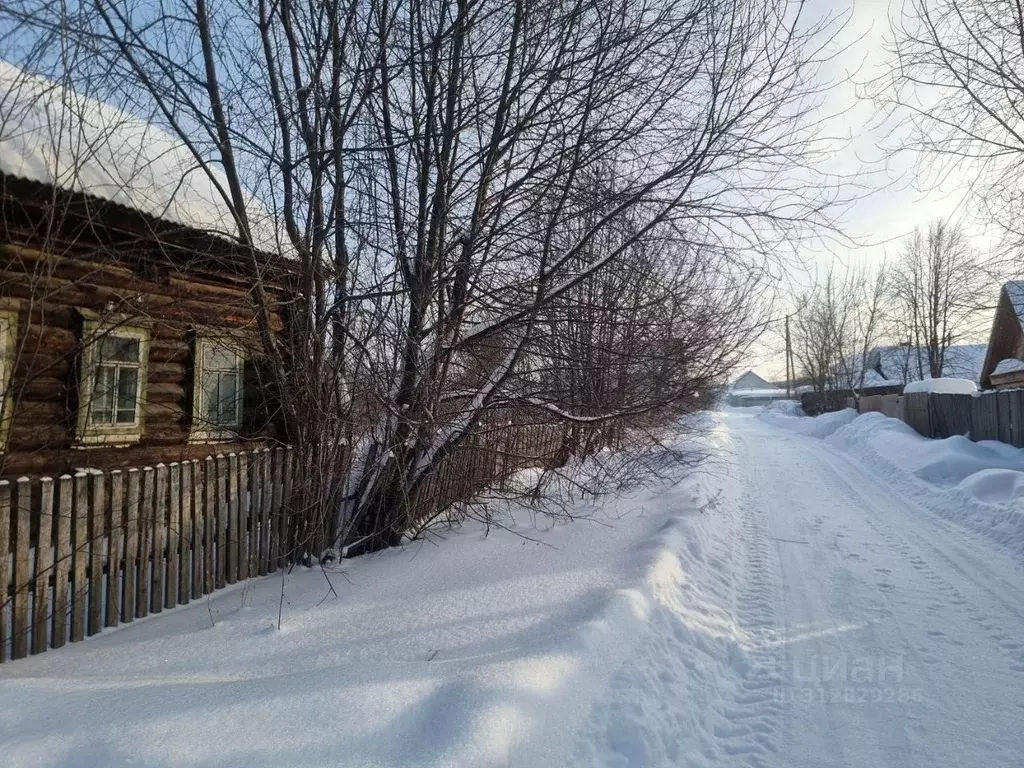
left=78, top=319, right=150, bottom=444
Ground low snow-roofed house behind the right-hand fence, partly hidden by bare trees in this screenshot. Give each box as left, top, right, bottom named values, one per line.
left=844, top=344, right=985, bottom=395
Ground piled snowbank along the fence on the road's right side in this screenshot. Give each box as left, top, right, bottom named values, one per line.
left=775, top=412, right=1024, bottom=554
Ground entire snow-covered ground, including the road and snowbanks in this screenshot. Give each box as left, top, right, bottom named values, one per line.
left=0, top=410, right=1024, bottom=768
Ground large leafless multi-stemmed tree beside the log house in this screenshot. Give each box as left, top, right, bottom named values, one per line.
left=2, top=0, right=831, bottom=557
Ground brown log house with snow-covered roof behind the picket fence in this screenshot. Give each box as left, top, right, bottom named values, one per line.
left=0, top=61, right=286, bottom=475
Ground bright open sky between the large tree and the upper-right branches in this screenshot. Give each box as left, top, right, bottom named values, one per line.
left=737, top=0, right=995, bottom=378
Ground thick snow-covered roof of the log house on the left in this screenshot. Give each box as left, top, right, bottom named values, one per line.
left=0, top=60, right=281, bottom=253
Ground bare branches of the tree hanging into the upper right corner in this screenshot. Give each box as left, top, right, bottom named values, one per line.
left=873, top=0, right=1024, bottom=253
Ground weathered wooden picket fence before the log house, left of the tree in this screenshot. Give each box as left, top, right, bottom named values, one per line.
left=0, top=447, right=292, bottom=662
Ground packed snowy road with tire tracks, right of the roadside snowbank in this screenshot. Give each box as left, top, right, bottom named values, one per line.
left=728, top=414, right=1024, bottom=768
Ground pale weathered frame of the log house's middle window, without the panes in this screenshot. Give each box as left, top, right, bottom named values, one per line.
left=75, top=310, right=150, bottom=447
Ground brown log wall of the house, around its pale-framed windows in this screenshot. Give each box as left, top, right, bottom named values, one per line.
left=0, top=244, right=284, bottom=479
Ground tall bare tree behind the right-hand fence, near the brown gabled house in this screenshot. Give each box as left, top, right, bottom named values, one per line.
left=889, top=219, right=988, bottom=379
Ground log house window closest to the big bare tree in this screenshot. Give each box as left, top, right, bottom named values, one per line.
left=191, top=335, right=245, bottom=441
